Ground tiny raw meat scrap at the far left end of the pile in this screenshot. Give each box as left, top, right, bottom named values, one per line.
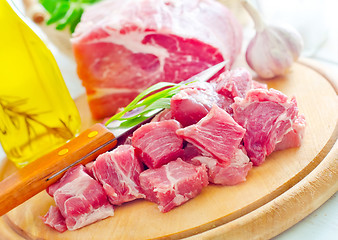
left=42, top=206, right=67, bottom=233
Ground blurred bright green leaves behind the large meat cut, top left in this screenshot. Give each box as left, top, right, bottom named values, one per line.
left=39, top=0, right=101, bottom=33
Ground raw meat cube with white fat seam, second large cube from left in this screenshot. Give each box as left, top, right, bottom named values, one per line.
left=92, top=145, right=145, bottom=205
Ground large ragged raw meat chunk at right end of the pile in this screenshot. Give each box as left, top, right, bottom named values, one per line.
left=232, top=89, right=298, bottom=166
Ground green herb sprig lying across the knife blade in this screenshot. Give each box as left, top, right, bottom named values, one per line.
left=105, top=82, right=189, bottom=128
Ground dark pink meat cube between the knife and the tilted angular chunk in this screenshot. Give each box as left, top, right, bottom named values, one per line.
left=132, top=120, right=183, bottom=168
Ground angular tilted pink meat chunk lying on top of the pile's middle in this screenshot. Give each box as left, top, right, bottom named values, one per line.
left=176, top=105, right=245, bottom=164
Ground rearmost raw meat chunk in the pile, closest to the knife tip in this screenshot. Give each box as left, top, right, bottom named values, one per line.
left=215, top=68, right=252, bottom=99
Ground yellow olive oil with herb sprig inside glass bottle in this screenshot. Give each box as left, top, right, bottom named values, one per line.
left=0, top=0, right=80, bottom=167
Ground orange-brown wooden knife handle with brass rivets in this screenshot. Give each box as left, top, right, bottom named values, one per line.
left=0, top=123, right=117, bottom=216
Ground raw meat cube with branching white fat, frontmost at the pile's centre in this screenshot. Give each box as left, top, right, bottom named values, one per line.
left=140, top=158, right=208, bottom=212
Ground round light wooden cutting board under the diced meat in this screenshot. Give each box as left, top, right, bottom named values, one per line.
left=0, top=59, right=338, bottom=240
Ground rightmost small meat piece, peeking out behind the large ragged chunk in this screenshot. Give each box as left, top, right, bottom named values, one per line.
left=274, top=115, right=306, bottom=151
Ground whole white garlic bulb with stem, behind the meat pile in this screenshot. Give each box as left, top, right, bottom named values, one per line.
left=242, top=1, right=303, bottom=78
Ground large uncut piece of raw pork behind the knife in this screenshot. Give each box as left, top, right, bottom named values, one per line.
left=72, top=0, right=242, bottom=119
